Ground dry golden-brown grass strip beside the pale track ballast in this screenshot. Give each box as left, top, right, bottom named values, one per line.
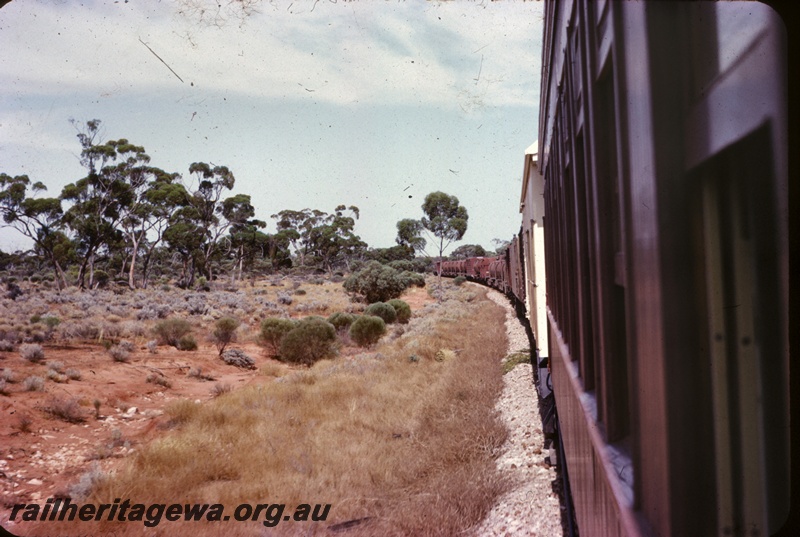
left=47, top=284, right=507, bottom=536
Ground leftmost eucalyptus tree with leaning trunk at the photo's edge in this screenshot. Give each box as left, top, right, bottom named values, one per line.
left=0, top=173, right=74, bottom=290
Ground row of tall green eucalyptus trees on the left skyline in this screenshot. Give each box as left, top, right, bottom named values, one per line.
left=0, top=119, right=440, bottom=293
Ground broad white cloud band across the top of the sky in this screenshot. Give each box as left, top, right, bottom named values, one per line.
left=0, top=1, right=541, bottom=109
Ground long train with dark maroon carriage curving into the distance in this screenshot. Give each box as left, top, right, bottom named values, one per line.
left=444, top=0, right=796, bottom=537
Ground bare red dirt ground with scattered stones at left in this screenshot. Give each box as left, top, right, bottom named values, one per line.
left=0, top=288, right=433, bottom=529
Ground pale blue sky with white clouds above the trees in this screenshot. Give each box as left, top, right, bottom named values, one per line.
left=0, top=0, right=543, bottom=253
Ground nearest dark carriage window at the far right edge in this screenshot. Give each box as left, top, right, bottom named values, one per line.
left=696, top=128, right=789, bottom=535
